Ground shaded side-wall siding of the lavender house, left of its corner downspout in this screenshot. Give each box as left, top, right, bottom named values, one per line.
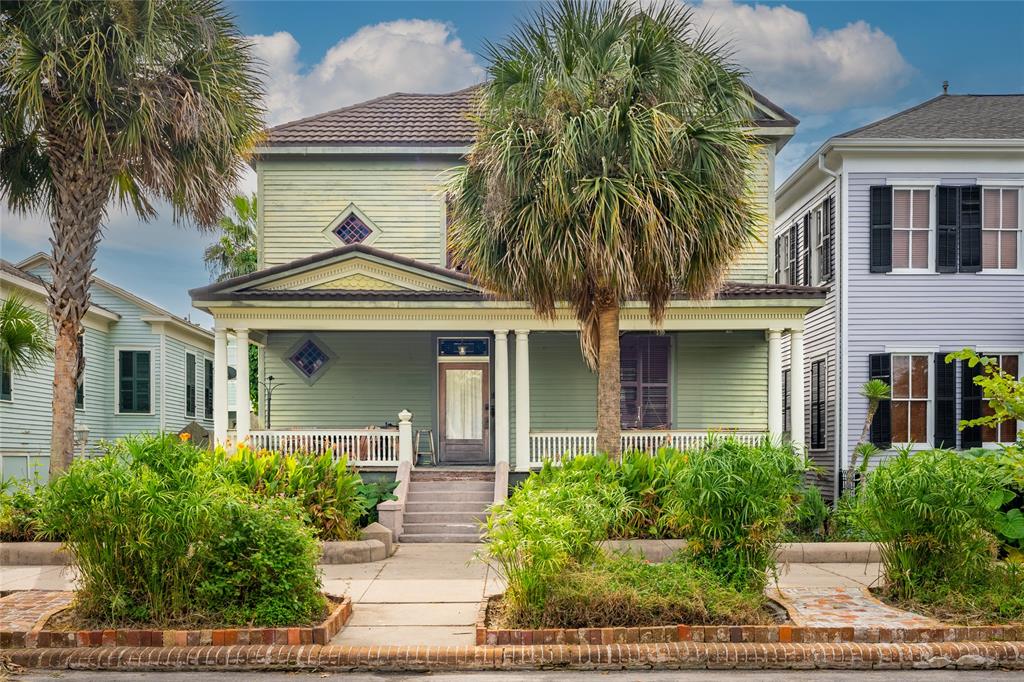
left=772, top=179, right=840, bottom=493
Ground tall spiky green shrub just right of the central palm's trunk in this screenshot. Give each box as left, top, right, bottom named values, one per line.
left=674, top=438, right=806, bottom=590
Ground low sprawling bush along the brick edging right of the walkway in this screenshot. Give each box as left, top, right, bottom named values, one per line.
left=494, top=554, right=772, bottom=628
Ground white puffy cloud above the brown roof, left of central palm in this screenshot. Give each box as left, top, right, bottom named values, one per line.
left=250, top=19, right=483, bottom=125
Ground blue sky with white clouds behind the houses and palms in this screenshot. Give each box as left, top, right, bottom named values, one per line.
left=0, top=0, right=1024, bottom=325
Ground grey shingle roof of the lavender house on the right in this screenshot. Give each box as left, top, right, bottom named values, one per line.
left=837, top=94, right=1024, bottom=139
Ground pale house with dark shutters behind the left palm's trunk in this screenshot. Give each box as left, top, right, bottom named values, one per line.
left=0, top=254, right=213, bottom=481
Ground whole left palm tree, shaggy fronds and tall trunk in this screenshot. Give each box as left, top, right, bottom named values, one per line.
left=0, top=0, right=262, bottom=476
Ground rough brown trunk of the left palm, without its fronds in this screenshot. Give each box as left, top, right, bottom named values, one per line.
left=49, top=131, right=113, bottom=473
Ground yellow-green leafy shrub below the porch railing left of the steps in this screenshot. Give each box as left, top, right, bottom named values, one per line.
left=220, top=446, right=368, bottom=540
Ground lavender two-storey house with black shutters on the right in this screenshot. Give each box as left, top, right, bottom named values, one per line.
left=773, top=94, right=1024, bottom=498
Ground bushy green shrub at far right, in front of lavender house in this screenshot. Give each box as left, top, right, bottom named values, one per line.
left=854, top=450, right=1002, bottom=599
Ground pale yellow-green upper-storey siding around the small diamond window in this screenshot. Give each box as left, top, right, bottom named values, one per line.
left=257, top=157, right=459, bottom=267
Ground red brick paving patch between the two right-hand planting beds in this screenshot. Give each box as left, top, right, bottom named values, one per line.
left=768, top=587, right=942, bottom=629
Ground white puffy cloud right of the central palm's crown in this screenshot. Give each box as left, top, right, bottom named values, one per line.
left=694, top=0, right=913, bottom=113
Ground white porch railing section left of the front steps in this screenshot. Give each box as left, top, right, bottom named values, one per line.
left=249, top=429, right=398, bottom=467
